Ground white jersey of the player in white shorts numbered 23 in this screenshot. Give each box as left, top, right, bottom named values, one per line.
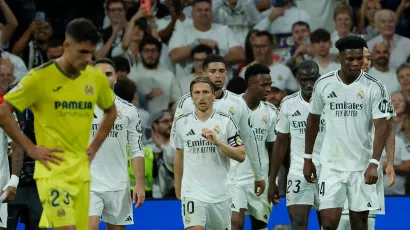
left=276, top=91, right=326, bottom=177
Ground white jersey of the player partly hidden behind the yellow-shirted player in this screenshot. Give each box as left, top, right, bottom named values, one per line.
left=90, top=96, right=144, bottom=192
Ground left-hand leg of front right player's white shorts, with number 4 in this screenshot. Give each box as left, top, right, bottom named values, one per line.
left=318, top=167, right=347, bottom=210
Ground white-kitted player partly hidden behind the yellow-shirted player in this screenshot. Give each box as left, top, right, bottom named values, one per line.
left=89, top=58, right=145, bottom=230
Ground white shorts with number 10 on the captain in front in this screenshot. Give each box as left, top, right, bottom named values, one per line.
left=181, top=197, right=232, bottom=230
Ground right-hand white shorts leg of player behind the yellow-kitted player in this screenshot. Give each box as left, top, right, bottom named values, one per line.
left=102, top=188, right=134, bottom=225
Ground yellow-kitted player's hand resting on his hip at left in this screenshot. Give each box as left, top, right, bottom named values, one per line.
left=27, top=146, right=64, bottom=170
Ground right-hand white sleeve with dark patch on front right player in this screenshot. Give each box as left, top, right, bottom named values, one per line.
left=370, top=84, right=393, bottom=120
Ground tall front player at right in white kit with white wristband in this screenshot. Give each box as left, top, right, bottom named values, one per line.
left=303, top=35, right=390, bottom=230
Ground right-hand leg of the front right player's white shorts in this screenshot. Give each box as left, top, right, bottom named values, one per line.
left=347, top=171, right=380, bottom=212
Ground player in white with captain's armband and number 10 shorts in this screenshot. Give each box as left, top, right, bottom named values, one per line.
left=172, top=77, right=245, bottom=230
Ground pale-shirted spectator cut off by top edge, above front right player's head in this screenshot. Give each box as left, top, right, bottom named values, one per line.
left=295, top=0, right=339, bottom=31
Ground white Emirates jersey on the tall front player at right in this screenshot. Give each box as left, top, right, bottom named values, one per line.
left=309, top=71, right=391, bottom=171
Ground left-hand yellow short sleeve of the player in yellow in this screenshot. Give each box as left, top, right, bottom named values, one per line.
left=4, top=71, right=42, bottom=112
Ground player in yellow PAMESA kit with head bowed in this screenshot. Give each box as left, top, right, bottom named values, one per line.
left=4, top=19, right=117, bottom=230
